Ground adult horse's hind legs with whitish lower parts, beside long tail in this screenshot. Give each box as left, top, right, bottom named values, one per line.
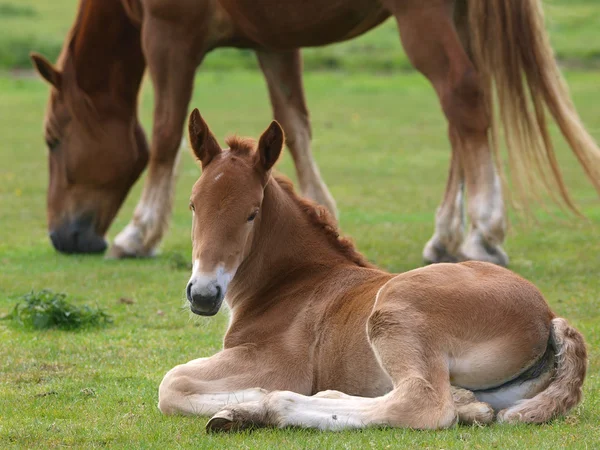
left=390, top=0, right=508, bottom=265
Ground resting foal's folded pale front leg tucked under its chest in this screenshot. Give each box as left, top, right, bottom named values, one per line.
left=158, top=348, right=306, bottom=415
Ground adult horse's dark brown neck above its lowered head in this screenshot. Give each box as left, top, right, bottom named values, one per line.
left=63, top=0, right=145, bottom=112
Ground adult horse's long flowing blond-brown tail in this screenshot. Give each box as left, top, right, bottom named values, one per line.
left=466, top=0, right=600, bottom=212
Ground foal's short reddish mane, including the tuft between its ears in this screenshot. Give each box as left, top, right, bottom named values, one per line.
left=225, top=136, right=374, bottom=267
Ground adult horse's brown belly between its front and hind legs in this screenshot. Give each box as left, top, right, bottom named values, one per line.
left=219, top=0, right=389, bottom=49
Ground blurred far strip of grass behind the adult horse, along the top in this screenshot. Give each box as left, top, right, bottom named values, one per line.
left=0, top=0, right=600, bottom=72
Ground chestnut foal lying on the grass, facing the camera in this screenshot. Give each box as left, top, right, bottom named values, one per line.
left=158, top=110, right=587, bottom=430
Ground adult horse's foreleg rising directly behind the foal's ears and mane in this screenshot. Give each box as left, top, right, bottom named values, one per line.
left=257, top=50, right=337, bottom=215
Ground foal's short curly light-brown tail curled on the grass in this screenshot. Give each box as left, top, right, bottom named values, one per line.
left=498, top=318, right=587, bottom=423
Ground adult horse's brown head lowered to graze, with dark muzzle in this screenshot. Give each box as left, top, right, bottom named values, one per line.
left=32, top=54, right=148, bottom=253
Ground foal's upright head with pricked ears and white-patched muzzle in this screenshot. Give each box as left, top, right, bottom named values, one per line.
left=186, top=109, right=284, bottom=316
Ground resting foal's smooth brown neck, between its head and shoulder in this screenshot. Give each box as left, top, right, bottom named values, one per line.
left=228, top=179, right=352, bottom=308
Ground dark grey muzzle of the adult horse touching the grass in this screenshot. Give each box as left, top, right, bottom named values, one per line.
left=49, top=219, right=106, bottom=253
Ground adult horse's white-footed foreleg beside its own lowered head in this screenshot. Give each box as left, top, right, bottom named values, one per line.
left=109, top=16, right=201, bottom=258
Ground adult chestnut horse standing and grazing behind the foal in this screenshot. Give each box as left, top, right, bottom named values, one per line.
left=32, top=0, right=600, bottom=264
